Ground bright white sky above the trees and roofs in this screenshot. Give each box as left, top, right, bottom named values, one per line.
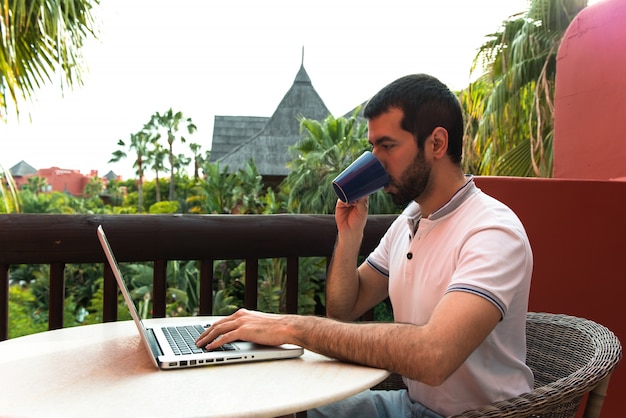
left=0, top=0, right=527, bottom=178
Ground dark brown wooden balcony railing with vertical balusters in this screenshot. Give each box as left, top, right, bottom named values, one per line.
left=0, top=214, right=395, bottom=341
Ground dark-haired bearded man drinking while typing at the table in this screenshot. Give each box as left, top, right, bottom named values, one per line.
left=198, top=74, right=533, bottom=417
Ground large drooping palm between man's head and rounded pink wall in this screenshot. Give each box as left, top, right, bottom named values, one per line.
left=462, top=0, right=587, bottom=177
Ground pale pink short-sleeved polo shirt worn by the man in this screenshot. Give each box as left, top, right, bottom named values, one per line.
left=367, top=178, right=533, bottom=415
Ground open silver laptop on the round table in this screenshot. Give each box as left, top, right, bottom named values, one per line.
left=98, top=225, right=304, bottom=369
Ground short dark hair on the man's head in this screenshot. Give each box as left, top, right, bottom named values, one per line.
left=363, top=74, right=463, bottom=164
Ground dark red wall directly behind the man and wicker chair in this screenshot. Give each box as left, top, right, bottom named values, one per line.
left=476, top=176, right=626, bottom=418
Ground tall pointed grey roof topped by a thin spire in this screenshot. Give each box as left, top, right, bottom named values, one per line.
left=211, top=65, right=330, bottom=176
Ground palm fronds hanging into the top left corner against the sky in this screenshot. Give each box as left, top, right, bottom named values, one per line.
left=0, top=0, right=99, bottom=212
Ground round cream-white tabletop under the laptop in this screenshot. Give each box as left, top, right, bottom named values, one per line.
left=0, top=318, right=389, bottom=418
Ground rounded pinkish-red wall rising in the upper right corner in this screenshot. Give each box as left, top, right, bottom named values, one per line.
left=553, top=0, right=626, bottom=180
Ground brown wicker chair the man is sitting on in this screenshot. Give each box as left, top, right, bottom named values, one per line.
left=377, top=313, right=622, bottom=418
